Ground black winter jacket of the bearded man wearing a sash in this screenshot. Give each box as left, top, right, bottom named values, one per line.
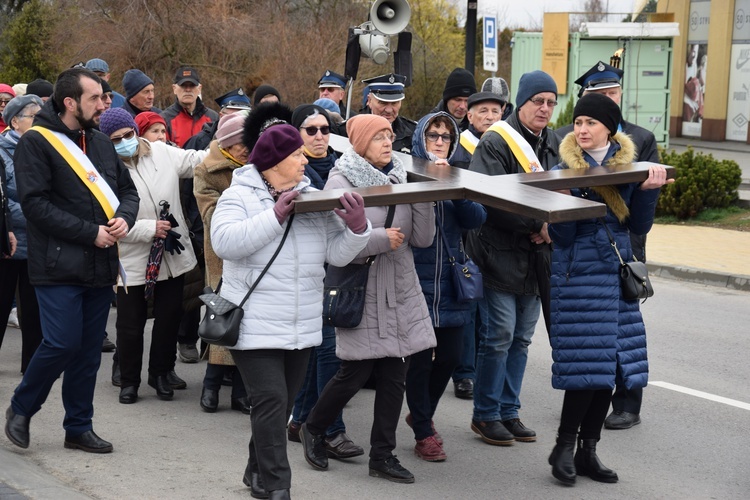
left=15, top=99, right=138, bottom=288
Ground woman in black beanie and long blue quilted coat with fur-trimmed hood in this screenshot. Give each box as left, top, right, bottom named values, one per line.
left=549, top=94, right=673, bottom=484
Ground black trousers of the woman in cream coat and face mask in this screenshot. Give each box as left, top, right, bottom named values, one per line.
left=116, top=276, right=185, bottom=387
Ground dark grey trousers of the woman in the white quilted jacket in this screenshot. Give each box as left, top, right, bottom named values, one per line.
left=231, top=348, right=312, bottom=491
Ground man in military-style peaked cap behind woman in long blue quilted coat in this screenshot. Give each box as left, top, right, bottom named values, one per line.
left=555, top=61, right=659, bottom=429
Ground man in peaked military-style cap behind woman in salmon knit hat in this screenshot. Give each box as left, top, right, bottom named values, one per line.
left=362, top=73, right=417, bottom=153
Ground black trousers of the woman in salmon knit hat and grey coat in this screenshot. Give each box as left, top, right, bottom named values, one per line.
left=306, top=357, right=409, bottom=460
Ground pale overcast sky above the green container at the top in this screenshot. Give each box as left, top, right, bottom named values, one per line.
left=453, top=0, right=635, bottom=29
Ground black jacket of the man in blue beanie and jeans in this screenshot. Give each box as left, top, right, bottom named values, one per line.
left=466, top=111, right=559, bottom=295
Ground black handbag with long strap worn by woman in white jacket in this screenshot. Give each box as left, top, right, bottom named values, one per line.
left=198, top=214, right=294, bottom=347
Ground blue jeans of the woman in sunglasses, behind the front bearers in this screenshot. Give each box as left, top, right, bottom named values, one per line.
left=292, top=326, right=346, bottom=437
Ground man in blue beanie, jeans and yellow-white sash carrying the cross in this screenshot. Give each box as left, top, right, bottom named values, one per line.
left=466, top=71, right=559, bottom=446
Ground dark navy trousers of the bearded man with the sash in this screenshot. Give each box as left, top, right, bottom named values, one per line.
left=11, top=285, right=113, bottom=437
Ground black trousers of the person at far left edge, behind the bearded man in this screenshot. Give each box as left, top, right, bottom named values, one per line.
left=0, top=259, right=42, bottom=373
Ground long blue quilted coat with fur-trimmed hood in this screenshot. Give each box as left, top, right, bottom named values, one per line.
left=549, top=133, right=659, bottom=390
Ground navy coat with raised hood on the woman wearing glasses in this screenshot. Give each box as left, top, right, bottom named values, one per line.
left=412, top=111, right=487, bottom=328
